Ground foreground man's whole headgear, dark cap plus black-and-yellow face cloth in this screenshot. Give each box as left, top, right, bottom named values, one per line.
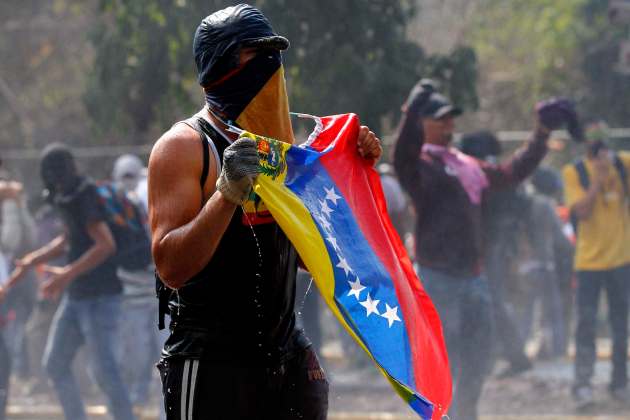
left=193, top=4, right=294, bottom=143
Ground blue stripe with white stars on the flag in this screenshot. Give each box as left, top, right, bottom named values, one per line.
left=285, top=147, right=414, bottom=388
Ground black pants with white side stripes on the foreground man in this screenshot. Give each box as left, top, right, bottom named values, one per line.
left=158, top=348, right=328, bottom=420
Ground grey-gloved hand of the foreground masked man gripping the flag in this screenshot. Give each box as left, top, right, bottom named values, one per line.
left=217, top=138, right=260, bottom=206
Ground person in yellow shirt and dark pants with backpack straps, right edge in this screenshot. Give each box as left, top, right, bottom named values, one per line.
left=562, top=120, right=630, bottom=408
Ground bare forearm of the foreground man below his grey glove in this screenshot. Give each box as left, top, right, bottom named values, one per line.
left=153, top=191, right=236, bottom=289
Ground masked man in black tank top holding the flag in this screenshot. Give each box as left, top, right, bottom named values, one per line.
left=148, top=4, right=382, bottom=420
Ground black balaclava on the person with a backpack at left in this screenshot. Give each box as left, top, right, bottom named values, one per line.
left=39, top=143, right=79, bottom=200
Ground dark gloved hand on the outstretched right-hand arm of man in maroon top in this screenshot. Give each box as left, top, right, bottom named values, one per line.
left=536, top=98, right=584, bottom=141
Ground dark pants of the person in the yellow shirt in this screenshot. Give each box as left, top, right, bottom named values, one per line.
left=575, top=266, right=630, bottom=389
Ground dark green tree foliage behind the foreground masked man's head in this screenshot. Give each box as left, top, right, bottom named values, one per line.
left=85, top=0, right=477, bottom=143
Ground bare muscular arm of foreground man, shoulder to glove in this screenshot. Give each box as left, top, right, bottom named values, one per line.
left=148, top=124, right=236, bottom=289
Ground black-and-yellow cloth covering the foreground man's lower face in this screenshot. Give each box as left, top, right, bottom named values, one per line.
left=206, top=50, right=295, bottom=143
